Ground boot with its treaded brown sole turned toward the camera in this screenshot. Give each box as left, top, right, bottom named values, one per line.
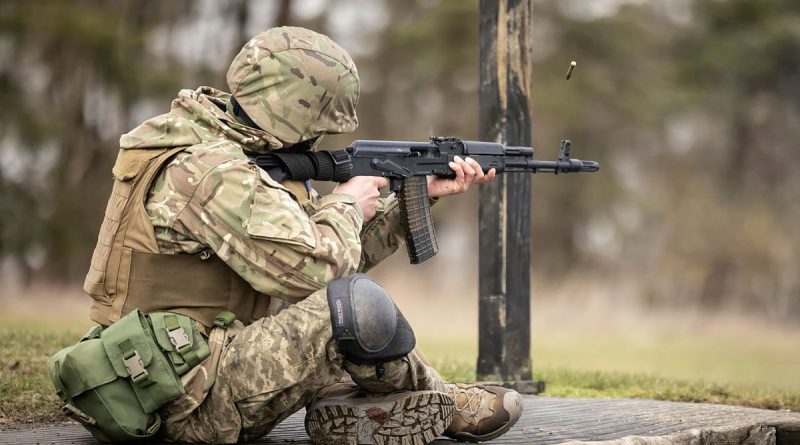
left=305, top=391, right=453, bottom=445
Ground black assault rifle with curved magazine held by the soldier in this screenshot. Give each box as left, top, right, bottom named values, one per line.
left=251, top=137, right=600, bottom=264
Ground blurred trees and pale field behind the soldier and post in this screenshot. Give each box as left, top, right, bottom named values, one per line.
left=0, top=0, right=800, bottom=398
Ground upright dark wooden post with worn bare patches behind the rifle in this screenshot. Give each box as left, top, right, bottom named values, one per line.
left=478, top=0, right=542, bottom=392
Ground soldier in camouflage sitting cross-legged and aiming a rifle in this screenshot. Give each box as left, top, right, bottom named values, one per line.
left=79, top=27, right=522, bottom=443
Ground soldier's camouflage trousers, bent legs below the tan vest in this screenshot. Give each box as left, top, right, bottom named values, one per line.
left=155, top=289, right=444, bottom=443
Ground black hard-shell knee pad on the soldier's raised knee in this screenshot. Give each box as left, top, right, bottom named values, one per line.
left=328, top=274, right=416, bottom=364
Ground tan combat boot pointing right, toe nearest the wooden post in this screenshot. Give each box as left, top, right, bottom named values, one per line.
left=444, top=383, right=522, bottom=442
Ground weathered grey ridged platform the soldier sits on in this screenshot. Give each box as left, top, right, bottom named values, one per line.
left=0, top=396, right=800, bottom=445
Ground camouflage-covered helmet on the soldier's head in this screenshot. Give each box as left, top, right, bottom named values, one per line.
left=226, top=26, right=359, bottom=146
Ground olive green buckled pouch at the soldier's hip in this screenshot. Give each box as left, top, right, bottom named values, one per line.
left=47, top=310, right=208, bottom=442
